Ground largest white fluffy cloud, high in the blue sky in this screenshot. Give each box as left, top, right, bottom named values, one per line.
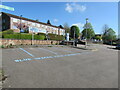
left=65, top=3, right=87, bottom=13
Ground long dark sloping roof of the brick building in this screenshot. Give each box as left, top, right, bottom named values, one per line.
left=2, top=12, right=63, bottom=29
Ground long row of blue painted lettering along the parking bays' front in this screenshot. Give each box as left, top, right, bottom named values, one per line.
left=14, top=52, right=92, bottom=62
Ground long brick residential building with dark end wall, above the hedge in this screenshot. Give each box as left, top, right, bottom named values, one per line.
left=0, top=12, right=65, bottom=35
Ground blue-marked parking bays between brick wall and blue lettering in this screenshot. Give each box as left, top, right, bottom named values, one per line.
left=2, top=47, right=90, bottom=62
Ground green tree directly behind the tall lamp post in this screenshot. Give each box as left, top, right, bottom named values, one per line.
left=82, top=23, right=95, bottom=39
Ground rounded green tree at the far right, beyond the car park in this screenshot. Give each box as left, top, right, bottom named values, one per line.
left=102, top=28, right=116, bottom=43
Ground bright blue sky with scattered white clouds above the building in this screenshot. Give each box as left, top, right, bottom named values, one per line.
left=3, top=2, right=118, bottom=34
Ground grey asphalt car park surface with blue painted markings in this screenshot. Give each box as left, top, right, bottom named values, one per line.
left=2, top=45, right=118, bottom=88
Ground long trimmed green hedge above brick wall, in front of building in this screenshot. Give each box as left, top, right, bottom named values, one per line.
left=1, top=29, right=65, bottom=40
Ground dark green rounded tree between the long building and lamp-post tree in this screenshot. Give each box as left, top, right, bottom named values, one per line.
left=70, top=26, right=80, bottom=39
